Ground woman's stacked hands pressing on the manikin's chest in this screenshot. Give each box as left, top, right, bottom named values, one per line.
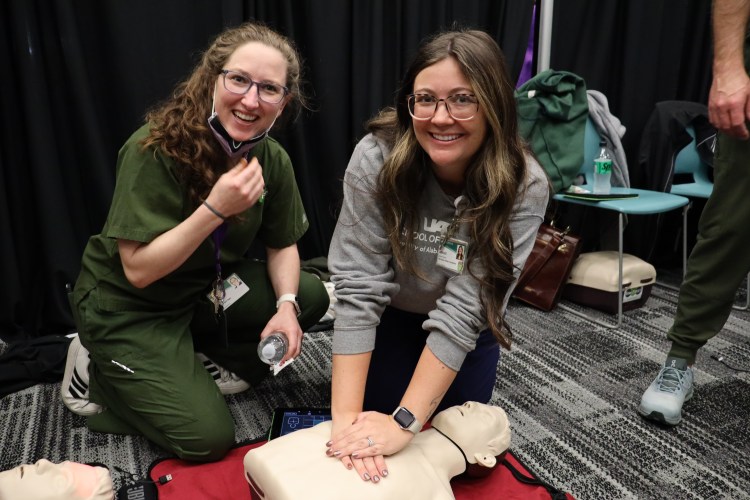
left=326, top=411, right=414, bottom=483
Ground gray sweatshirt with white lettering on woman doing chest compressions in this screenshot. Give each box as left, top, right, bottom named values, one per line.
left=328, top=134, right=549, bottom=371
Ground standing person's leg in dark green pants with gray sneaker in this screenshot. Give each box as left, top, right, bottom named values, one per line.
left=638, top=134, right=750, bottom=425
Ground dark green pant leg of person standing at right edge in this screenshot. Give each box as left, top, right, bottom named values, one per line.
left=667, top=133, right=750, bottom=364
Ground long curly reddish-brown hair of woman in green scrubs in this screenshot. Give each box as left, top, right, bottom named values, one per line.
left=143, top=22, right=308, bottom=206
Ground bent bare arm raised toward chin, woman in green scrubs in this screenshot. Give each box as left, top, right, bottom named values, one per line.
left=117, top=158, right=264, bottom=288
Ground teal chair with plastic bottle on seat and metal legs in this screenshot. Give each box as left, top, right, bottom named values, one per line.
left=554, top=118, right=690, bottom=328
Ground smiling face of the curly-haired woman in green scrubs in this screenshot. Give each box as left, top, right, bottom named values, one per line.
left=214, top=42, right=289, bottom=142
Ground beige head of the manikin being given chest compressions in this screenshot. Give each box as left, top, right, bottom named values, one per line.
left=432, top=401, right=510, bottom=471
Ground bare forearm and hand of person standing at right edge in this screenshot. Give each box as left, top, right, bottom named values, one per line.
left=708, top=0, right=750, bottom=139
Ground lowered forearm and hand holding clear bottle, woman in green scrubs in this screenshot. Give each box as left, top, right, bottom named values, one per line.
left=260, top=243, right=303, bottom=363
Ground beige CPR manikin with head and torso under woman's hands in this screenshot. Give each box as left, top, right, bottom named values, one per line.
left=244, top=402, right=510, bottom=500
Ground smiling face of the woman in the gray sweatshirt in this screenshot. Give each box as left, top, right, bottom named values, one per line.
left=412, top=57, right=487, bottom=194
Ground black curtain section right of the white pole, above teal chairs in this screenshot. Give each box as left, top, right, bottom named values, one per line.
left=550, top=0, right=711, bottom=187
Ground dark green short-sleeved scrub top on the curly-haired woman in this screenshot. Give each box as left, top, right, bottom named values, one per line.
left=73, top=124, right=309, bottom=311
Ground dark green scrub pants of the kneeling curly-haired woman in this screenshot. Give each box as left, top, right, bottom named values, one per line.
left=77, top=260, right=329, bottom=461
